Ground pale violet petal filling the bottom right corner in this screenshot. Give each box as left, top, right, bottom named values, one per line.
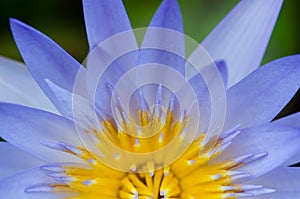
left=244, top=167, right=300, bottom=199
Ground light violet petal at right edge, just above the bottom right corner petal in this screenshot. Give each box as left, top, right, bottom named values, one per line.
left=216, top=125, right=300, bottom=178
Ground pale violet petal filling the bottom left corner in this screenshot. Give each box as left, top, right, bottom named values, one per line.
left=0, top=168, right=62, bottom=199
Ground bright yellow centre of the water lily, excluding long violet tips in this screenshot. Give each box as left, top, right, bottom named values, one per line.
left=51, top=107, right=247, bottom=199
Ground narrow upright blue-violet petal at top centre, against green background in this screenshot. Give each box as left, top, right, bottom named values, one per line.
left=139, top=0, right=185, bottom=75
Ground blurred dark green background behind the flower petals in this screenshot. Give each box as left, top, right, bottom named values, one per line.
left=0, top=0, right=300, bottom=116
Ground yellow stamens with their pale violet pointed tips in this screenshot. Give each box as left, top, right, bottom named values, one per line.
left=34, top=91, right=271, bottom=199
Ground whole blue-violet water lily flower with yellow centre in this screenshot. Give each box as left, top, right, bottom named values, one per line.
left=0, top=0, right=300, bottom=199
